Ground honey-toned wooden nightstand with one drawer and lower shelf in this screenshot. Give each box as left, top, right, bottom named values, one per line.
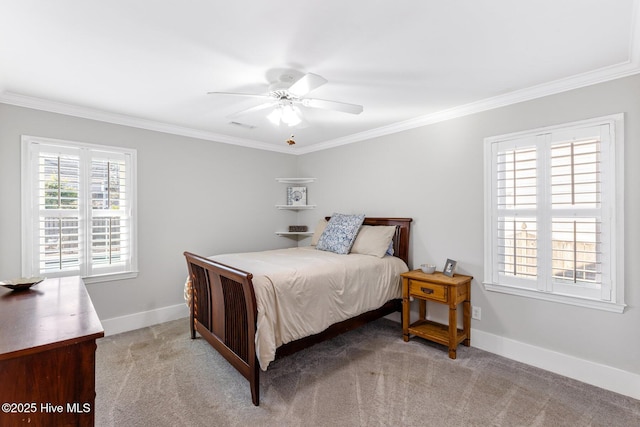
left=401, top=270, right=473, bottom=359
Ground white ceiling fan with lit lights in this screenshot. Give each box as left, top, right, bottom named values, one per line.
left=208, top=73, right=363, bottom=126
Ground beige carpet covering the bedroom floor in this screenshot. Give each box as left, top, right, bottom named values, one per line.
left=96, top=319, right=640, bottom=427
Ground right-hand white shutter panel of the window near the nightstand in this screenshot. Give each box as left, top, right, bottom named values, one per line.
left=549, top=124, right=615, bottom=301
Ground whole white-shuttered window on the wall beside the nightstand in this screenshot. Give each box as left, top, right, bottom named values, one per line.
left=484, top=114, right=625, bottom=312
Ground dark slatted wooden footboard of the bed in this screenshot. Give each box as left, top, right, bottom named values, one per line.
left=184, top=252, right=260, bottom=406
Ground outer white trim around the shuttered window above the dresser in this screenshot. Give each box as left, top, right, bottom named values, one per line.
left=21, top=135, right=138, bottom=283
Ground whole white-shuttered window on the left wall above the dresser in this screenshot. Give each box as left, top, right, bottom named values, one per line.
left=22, top=136, right=137, bottom=282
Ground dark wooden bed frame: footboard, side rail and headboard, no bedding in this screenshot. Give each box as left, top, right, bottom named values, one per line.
left=184, top=218, right=412, bottom=406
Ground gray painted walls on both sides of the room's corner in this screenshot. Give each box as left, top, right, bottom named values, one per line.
left=0, top=72, right=640, bottom=384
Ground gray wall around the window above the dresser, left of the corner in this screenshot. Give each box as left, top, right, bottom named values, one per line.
left=0, top=104, right=295, bottom=320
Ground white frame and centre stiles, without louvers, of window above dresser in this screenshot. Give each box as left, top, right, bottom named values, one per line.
left=21, top=135, right=138, bottom=283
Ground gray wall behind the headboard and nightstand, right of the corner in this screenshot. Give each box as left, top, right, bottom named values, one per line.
left=298, top=75, right=640, bottom=373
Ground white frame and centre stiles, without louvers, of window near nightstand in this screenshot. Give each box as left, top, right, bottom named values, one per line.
left=483, top=113, right=626, bottom=313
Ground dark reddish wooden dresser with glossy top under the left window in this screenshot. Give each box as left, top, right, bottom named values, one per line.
left=0, top=277, right=104, bottom=426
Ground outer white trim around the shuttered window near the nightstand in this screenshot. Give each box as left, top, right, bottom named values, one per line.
left=483, top=113, right=626, bottom=313
